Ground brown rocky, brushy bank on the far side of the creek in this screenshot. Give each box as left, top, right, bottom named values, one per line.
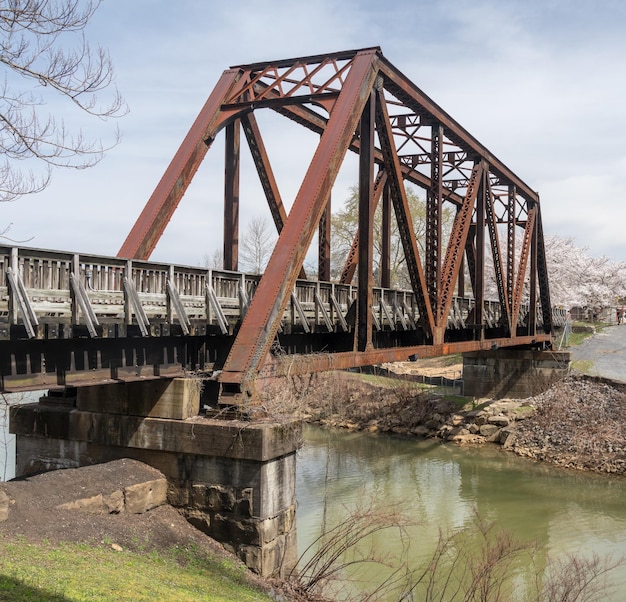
left=258, top=367, right=626, bottom=474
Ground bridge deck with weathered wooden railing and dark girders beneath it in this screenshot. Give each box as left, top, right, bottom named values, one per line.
left=0, top=247, right=562, bottom=391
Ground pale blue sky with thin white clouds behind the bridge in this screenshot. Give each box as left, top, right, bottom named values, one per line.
left=0, top=0, right=626, bottom=265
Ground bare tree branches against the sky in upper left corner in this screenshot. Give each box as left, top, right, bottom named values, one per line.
left=0, top=0, right=126, bottom=201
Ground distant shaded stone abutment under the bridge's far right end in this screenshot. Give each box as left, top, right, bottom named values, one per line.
left=463, top=349, right=570, bottom=399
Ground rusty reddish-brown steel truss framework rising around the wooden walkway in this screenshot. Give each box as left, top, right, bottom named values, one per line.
left=118, top=48, right=552, bottom=404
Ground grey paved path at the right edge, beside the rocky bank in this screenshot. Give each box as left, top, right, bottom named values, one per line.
left=571, top=324, right=626, bottom=382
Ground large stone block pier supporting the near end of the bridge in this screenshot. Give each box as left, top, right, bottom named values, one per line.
left=10, top=379, right=301, bottom=576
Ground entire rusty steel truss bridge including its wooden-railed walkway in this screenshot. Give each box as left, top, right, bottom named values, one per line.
left=0, top=48, right=556, bottom=403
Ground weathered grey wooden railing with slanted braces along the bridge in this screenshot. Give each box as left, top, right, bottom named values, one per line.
left=0, top=247, right=565, bottom=339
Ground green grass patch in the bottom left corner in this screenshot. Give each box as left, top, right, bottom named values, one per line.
left=0, top=541, right=271, bottom=602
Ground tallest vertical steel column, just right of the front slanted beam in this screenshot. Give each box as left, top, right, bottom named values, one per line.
left=356, top=91, right=376, bottom=351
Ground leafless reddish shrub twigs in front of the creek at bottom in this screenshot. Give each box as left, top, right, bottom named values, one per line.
left=285, top=500, right=624, bottom=602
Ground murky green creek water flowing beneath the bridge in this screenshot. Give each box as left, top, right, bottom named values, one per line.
left=296, top=427, right=626, bottom=600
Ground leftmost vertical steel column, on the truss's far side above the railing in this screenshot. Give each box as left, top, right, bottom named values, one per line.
left=224, top=119, right=241, bottom=271
